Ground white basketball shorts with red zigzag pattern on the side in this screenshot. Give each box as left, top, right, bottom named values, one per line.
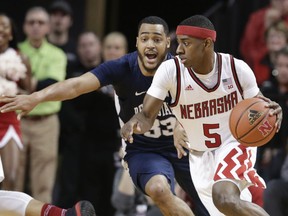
left=189, top=142, right=266, bottom=216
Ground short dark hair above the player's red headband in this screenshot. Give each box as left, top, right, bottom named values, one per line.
left=179, top=15, right=215, bottom=31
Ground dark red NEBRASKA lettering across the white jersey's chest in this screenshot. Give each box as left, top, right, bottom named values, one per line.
left=179, top=91, right=238, bottom=119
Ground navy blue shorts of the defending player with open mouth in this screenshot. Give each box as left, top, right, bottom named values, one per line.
left=124, top=147, right=209, bottom=216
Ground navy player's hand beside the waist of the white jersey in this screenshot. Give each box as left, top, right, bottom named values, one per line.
left=173, top=124, right=190, bottom=159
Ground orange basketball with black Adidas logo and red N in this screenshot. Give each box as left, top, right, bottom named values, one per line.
left=229, top=98, right=277, bottom=147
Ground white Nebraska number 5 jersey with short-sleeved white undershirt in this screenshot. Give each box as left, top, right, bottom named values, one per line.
left=147, top=53, right=259, bottom=151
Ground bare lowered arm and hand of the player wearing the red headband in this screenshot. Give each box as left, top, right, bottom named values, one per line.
left=121, top=94, right=163, bottom=143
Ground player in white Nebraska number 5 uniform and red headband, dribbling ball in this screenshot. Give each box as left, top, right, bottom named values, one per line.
left=121, top=15, right=282, bottom=216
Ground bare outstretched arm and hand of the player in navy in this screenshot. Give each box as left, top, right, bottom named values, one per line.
left=0, top=72, right=100, bottom=117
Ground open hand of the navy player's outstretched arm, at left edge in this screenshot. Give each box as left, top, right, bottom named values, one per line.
left=0, top=95, right=37, bottom=119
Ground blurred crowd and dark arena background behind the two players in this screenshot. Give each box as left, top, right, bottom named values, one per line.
left=0, top=0, right=288, bottom=216
